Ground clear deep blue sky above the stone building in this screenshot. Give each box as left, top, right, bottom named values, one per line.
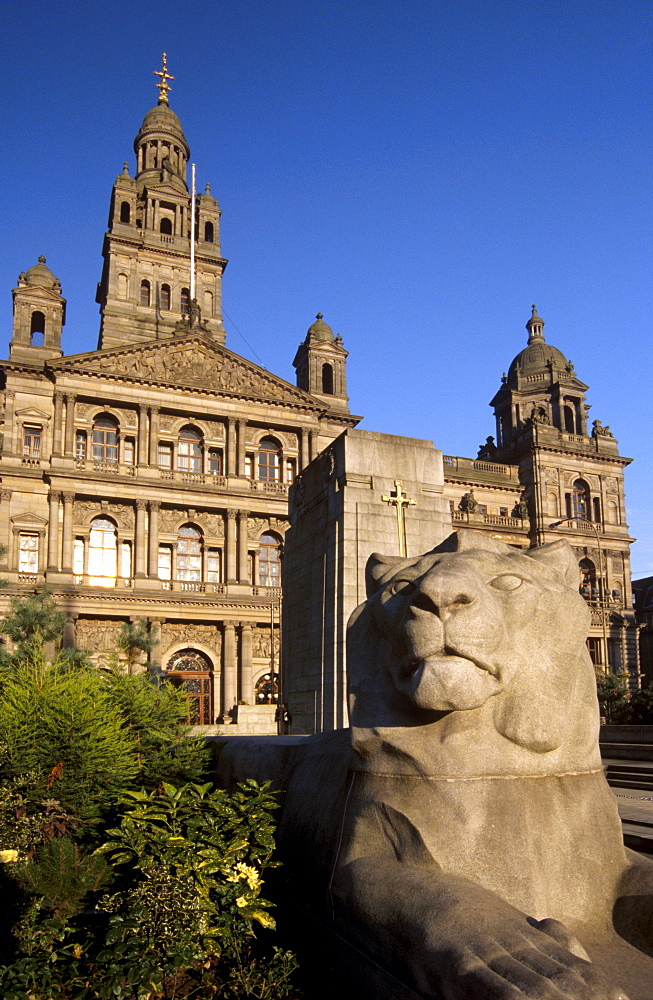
left=0, top=0, right=653, bottom=576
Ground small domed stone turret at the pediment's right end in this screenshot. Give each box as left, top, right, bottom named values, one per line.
left=293, top=313, right=349, bottom=413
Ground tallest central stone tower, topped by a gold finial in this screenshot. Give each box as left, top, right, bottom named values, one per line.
left=97, top=53, right=227, bottom=349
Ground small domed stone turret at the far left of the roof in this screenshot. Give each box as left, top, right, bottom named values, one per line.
left=9, top=256, right=66, bottom=364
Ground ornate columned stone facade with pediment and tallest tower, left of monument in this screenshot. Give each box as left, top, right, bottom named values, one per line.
left=0, top=63, right=358, bottom=724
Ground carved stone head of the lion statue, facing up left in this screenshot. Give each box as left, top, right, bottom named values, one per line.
left=348, top=530, right=596, bottom=753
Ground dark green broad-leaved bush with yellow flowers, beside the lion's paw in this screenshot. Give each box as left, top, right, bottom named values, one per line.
left=0, top=782, right=296, bottom=1000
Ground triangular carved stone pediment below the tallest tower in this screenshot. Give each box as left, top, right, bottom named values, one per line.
left=57, top=335, right=317, bottom=408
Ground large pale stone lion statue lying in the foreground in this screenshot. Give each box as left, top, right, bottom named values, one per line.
left=219, top=531, right=653, bottom=1000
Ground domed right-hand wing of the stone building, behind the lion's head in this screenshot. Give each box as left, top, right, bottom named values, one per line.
left=444, top=306, right=640, bottom=688
